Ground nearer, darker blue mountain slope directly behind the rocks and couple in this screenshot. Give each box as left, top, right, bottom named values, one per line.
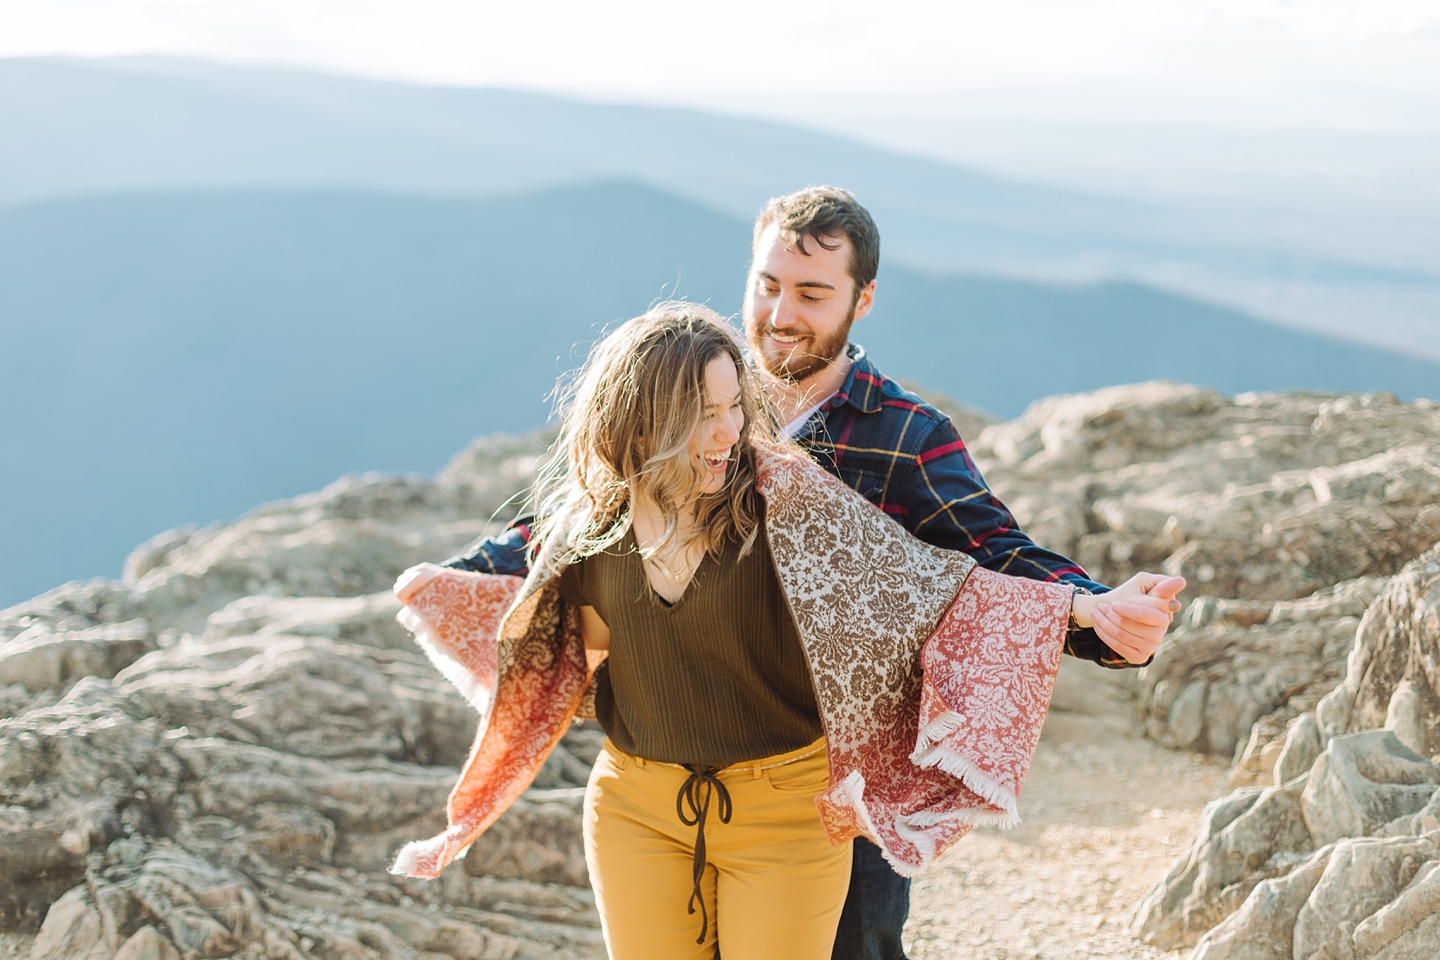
left=0, top=183, right=1440, bottom=604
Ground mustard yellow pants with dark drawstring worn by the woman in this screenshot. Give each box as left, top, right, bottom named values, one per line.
left=585, top=740, right=851, bottom=960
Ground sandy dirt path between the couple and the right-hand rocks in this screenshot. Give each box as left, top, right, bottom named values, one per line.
left=906, top=658, right=1225, bottom=960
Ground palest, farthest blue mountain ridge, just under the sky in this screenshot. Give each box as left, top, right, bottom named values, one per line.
left=0, top=58, right=1399, bottom=284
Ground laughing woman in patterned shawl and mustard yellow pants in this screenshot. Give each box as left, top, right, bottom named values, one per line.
left=395, top=304, right=1096, bottom=960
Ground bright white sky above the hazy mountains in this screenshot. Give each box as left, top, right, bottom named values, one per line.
left=8, top=0, right=1440, bottom=113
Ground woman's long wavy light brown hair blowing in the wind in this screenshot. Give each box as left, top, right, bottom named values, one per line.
left=531, top=301, right=775, bottom=563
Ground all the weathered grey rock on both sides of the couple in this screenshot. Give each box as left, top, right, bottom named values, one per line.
left=11, top=383, right=1440, bottom=960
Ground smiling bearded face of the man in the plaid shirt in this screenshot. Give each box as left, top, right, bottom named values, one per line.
left=744, top=225, right=876, bottom=380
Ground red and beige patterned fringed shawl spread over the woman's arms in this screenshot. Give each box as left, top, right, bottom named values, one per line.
left=390, top=449, right=1071, bottom=877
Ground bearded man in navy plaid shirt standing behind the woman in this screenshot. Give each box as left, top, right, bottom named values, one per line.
left=446, top=187, right=1185, bottom=960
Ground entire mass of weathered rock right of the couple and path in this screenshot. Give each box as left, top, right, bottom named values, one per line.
left=973, top=384, right=1440, bottom=960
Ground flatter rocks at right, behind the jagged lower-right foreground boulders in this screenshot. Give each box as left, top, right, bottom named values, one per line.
left=973, top=383, right=1440, bottom=765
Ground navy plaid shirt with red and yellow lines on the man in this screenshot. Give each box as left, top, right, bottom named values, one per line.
left=445, top=344, right=1130, bottom=668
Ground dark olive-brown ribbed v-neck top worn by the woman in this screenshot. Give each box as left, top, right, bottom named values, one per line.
left=560, top=518, right=824, bottom=767
